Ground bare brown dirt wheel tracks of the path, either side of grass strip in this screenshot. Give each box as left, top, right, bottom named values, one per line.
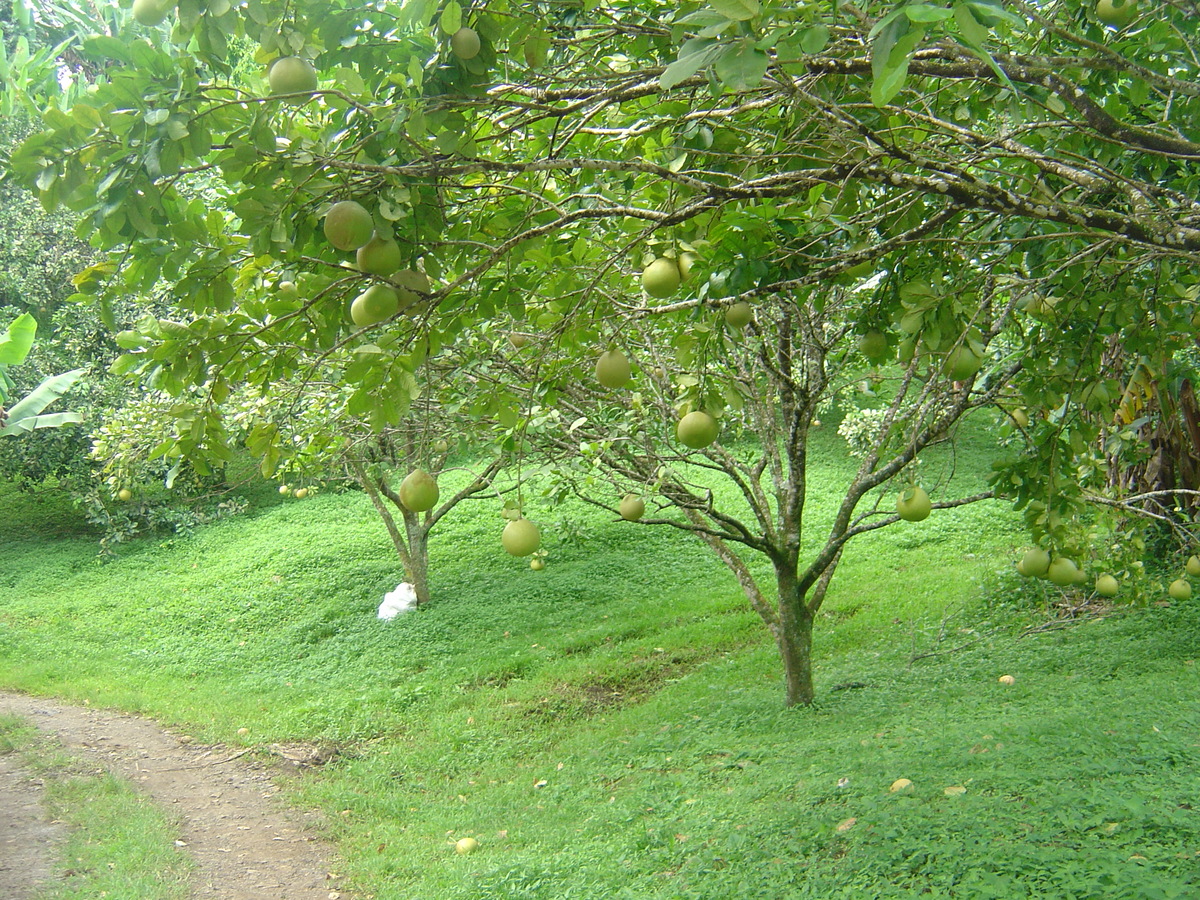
left=0, top=691, right=349, bottom=900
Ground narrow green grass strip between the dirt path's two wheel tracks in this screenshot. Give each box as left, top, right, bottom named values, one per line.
left=0, top=716, right=191, bottom=900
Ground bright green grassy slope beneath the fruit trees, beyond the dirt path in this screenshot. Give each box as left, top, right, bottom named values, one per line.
left=0, top=424, right=1200, bottom=900
